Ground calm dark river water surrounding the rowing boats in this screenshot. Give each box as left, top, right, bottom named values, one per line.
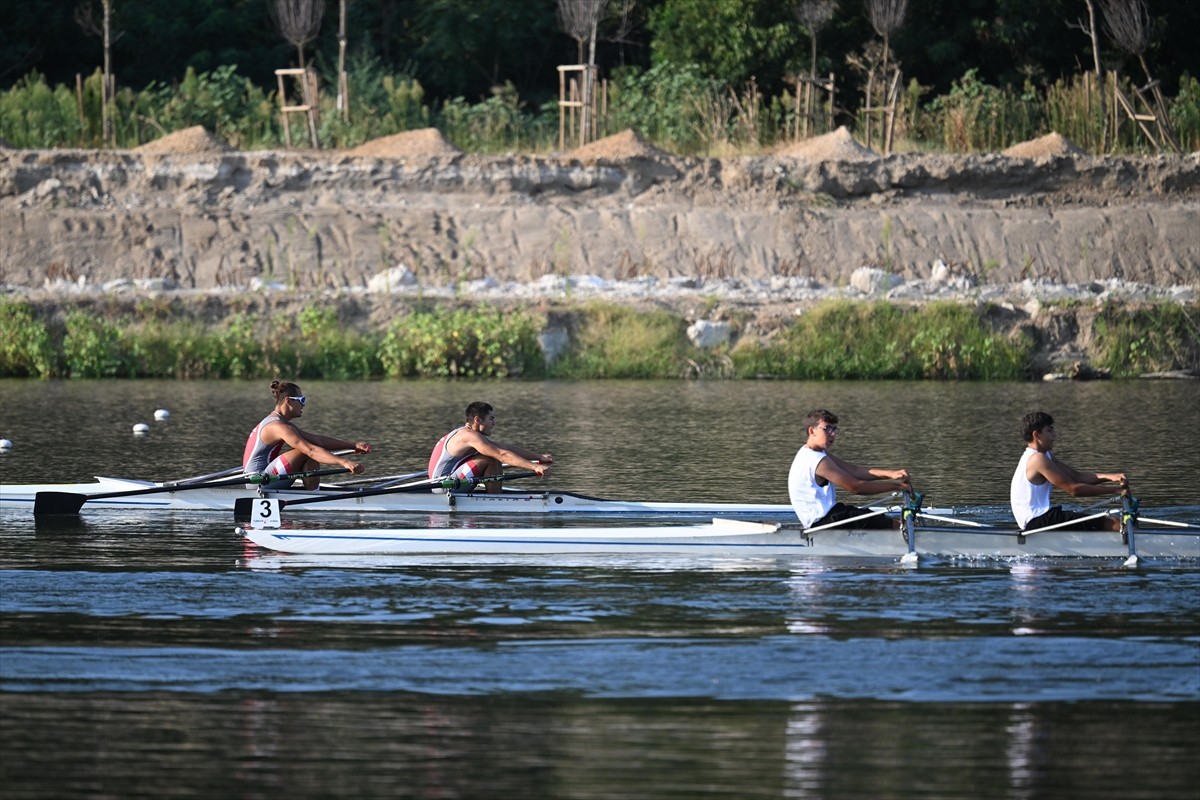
left=0, top=381, right=1200, bottom=800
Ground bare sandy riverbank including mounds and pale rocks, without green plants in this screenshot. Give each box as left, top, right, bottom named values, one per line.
left=0, top=128, right=1200, bottom=377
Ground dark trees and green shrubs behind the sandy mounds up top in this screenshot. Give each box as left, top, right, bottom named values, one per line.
left=0, top=0, right=1200, bottom=155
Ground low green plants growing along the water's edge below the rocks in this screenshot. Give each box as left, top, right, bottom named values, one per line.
left=7, top=300, right=1200, bottom=380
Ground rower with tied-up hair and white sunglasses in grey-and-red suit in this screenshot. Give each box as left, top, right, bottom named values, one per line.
left=241, top=380, right=371, bottom=489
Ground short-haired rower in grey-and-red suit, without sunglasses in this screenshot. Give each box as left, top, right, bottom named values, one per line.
left=428, top=401, right=554, bottom=492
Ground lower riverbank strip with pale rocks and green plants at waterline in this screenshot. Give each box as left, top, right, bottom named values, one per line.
left=0, top=291, right=1200, bottom=380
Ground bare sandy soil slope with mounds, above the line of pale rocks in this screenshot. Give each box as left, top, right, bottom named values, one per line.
left=0, top=128, right=1200, bottom=296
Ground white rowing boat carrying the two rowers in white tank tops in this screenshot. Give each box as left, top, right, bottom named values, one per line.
left=236, top=518, right=1200, bottom=565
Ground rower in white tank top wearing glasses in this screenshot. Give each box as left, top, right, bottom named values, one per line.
left=787, top=409, right=912, bottom=529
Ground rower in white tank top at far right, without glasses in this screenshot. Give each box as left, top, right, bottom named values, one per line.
left=1009, top=411, right=1129, bottom=530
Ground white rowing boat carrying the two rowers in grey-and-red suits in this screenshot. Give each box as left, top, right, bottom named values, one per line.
left=0, top=477, right=794, bottom=518
